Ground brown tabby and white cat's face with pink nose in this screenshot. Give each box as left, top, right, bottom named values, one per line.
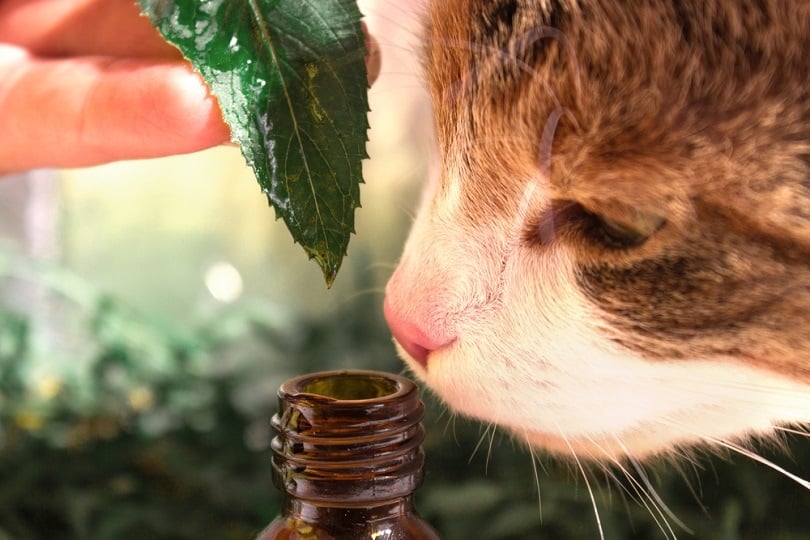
left=385, top=0, right=810, bottom=459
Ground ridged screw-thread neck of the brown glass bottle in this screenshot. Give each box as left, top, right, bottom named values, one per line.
left=272, top=372, right=424, bottom=504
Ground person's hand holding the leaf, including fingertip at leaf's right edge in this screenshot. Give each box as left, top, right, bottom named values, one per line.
left=0, top=0, right=379, bottom=172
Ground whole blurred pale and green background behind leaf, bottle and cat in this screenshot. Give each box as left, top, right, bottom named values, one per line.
left=0, top=0, right=810, bottom=540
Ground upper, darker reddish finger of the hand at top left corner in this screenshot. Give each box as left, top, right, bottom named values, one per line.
left=0, top=0, right=182, bottom=59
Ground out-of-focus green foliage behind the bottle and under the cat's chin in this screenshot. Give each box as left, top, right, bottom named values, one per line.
left=0, top=247, right=810, bottom=540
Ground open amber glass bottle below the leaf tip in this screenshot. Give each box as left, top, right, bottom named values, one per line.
left=257, top=371, right=438, bottom=540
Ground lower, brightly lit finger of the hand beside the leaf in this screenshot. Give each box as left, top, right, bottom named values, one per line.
left=0, top=46, right=230, bottom=172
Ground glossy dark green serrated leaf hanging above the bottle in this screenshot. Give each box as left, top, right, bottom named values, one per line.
left=139, top=0, right=368, bottom=286
